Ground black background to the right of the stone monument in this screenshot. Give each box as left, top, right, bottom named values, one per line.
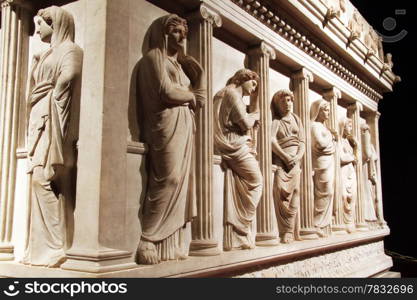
left=351, top=0, right=417, bottom=258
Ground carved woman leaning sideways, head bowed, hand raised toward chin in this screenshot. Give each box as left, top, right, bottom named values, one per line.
left=214, top=69, right=262, bottom=250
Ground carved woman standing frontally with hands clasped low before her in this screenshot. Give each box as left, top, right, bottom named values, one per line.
left=272, top=90, right=305, bottom=243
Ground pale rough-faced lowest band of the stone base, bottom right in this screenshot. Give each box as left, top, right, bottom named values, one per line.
left=234, top=241, right=392, bottom=278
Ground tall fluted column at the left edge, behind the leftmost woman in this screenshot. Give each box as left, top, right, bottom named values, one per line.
left=0, top=0, right=31, bottom=260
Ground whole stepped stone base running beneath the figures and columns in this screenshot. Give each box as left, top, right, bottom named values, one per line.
left=0, top=229, right=392, bottom=278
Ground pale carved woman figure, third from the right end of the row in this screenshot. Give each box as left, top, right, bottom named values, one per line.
left=310, top=99, right=337, bottom=237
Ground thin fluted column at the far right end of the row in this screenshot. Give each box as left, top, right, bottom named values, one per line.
left=368, top=111, right=387, bottom=226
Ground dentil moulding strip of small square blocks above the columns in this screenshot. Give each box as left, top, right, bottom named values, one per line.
left=230, top=0, right=382, bottom=102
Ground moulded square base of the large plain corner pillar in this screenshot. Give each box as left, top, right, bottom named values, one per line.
left=61, top=248, right=137, bottom=273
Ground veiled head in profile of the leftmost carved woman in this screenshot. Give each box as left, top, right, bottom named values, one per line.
left=35, top=6, right=75, bottom=45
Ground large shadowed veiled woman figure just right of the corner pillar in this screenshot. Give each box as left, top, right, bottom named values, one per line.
left=138, top=15, right=206, bottom=264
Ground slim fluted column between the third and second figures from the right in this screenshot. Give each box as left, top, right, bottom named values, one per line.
left=323, top=87, right=347, bottom=234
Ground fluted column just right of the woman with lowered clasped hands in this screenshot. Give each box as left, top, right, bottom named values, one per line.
left=290, top=68, right=318, bottom=239
